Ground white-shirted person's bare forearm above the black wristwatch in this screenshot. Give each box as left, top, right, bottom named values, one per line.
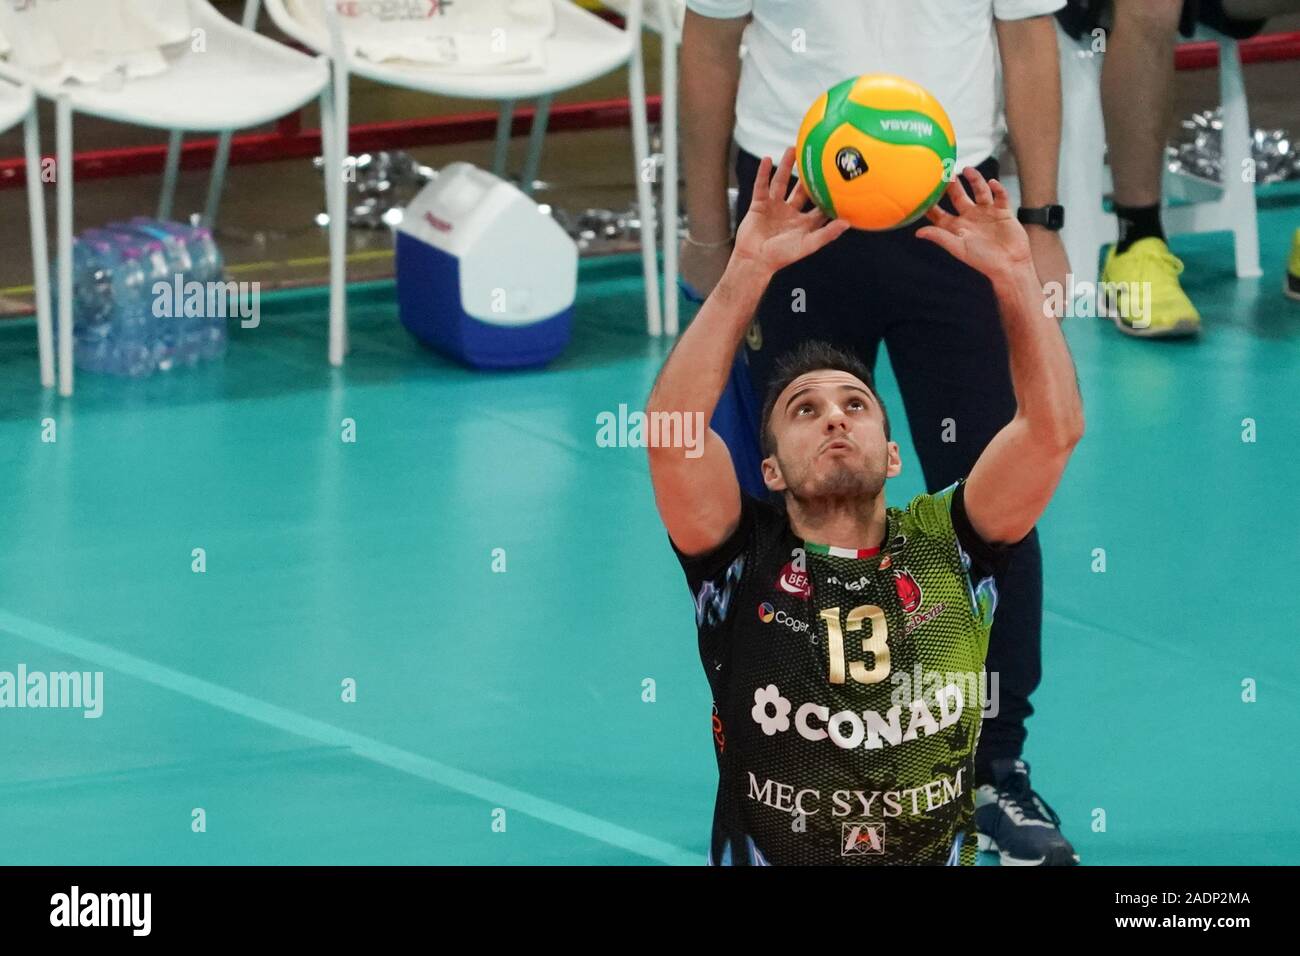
left=997, top=17, right=1061, bottom=208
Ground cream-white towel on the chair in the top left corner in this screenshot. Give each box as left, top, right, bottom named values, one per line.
left=0, top=0, right=190, bottom=83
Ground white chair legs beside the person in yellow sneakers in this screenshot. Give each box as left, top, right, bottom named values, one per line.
left=1057, top=23, right=1262, bottom=295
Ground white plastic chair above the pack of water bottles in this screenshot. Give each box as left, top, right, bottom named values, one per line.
left=2, top=0, right=333, bottom=395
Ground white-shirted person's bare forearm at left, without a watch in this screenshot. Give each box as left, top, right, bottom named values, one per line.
left=681, top=9, right=746, bottom=242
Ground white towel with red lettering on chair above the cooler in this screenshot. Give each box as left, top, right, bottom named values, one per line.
left=287, top=0, right=553, bottom=73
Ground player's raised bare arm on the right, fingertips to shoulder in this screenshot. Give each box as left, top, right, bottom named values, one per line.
left=918, top=168, right=1083, bottom=544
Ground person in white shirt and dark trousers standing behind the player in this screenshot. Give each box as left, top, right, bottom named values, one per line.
left=681, top=0, right=1078, bottom=864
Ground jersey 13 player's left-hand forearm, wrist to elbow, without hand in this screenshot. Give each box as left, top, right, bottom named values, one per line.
left=647, top=255, right=771, bottom=420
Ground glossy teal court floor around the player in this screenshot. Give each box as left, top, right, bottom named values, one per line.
left=0, top=190, right=1300, bottom=865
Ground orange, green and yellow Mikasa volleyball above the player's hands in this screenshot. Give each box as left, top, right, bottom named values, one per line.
left=798, top=73, right=957, bottom=232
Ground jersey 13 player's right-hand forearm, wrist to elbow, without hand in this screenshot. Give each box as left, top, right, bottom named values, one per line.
left=992, top=267, right=1083, bottom=449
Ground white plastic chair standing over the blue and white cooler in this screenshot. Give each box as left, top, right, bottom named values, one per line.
left=263, top=0, right=663, bottom=336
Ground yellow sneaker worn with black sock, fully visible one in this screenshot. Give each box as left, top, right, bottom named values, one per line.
left=1097, top=238, right=1201, bottom=338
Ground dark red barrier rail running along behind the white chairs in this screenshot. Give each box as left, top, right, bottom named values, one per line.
left=0, top=31, right=1300, bottom=189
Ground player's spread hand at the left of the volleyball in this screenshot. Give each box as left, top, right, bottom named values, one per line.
left=733, top=147, right=850, bottom=274
